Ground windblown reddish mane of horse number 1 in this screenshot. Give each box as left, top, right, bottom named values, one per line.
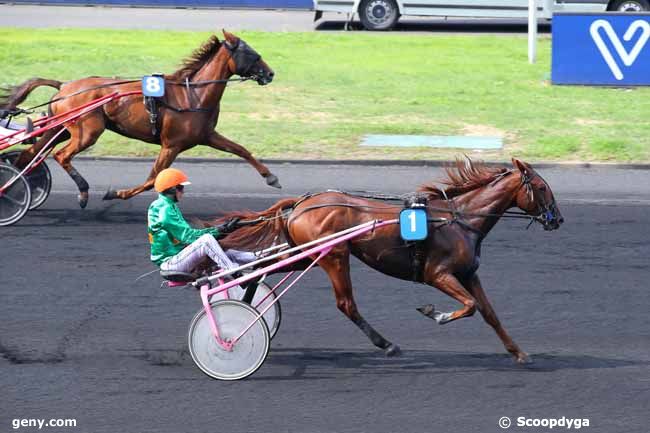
left=418, top=157, right=510, bottom=198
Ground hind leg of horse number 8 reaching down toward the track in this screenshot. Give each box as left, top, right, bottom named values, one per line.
left=54, top=113, right=104, bottom=209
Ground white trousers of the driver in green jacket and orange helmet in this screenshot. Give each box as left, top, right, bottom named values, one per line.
left=160, top=233, right=257, bottom=273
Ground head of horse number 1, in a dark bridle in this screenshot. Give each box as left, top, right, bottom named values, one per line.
left=512, top=158, right=564, bottom=230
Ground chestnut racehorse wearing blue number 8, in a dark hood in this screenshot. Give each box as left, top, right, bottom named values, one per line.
left=0, top=30, right=280, bottom=208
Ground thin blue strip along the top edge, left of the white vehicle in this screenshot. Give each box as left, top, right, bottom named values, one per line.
left=11, top=0, right=314, bottom=9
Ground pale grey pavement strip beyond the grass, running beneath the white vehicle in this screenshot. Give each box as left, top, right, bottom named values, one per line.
left=0, top=4, right=550, bottom=35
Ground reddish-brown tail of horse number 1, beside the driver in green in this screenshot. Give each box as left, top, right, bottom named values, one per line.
left=204, top=198, right=300, bottom=251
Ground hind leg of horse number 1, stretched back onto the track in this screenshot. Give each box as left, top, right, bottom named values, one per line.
left=319, top=252, right=400, bottom=356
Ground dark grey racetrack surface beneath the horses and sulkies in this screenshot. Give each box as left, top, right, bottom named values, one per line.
left=0, top=161, right=650, bottom=433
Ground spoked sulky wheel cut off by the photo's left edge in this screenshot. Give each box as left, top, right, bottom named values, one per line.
left=0, top=162, right=32, bottom=226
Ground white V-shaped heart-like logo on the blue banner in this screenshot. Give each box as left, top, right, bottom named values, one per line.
left=589, top=20, right=650, bottom=81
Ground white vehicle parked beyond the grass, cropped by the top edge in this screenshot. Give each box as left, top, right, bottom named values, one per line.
left=314, top=0, right=650, bottom=30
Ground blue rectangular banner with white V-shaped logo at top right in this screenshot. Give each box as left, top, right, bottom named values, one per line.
left=551, top=12, right=650, bottom=86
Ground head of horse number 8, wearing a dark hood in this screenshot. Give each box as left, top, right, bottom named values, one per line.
left=223, top=30, right=275, bottom=86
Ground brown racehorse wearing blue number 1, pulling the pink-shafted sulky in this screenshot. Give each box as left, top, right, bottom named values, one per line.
left=215, top=159, right=564, bottom=363
